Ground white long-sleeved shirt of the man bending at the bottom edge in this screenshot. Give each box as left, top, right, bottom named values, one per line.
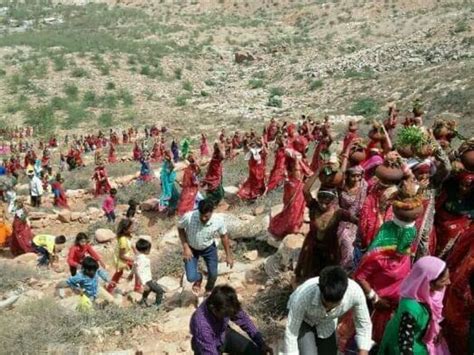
left=280, top=277, right=372, bottom=355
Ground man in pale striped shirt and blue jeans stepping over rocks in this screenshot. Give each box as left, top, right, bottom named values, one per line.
left=178, top=199, right=234, bottom=293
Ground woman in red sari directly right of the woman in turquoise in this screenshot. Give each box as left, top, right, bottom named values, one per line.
left=178, top=153, right=201, bottom=216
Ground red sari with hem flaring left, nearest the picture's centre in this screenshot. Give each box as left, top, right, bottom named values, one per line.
left=237, top=150, right=267, bottom=200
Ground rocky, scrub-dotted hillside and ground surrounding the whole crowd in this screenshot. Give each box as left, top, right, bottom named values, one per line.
left=0, top=0, right=474, bottom=354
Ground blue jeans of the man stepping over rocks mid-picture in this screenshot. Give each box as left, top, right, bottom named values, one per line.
left=184, top=243, right=219, bottom=291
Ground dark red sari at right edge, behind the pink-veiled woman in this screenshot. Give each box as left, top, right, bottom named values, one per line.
left=443, top=225, right=474, bottom=355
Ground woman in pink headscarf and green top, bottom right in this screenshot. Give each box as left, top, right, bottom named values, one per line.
left=379, top=256, right=450, bottom=355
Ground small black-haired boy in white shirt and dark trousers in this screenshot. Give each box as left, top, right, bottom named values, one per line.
left=131, top=239, right=165, bottom=307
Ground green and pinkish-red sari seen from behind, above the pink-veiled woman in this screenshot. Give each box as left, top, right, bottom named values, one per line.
left=353, top=218, right=417, bottom=343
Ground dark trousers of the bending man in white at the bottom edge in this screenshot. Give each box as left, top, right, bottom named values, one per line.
left=298, top=322, right=337, bottom=355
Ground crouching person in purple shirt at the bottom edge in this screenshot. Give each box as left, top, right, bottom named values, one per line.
left=190, top=285, right=273, bottom=355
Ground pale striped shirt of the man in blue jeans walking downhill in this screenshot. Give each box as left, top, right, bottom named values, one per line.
left=178, top=211, right=227, bottom=250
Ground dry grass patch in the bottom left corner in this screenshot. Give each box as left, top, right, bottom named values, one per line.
left=0, top=298, right=159, bottom=354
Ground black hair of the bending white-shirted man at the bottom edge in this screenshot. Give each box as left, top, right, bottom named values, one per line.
left=319, top=266, right=349, bottom=303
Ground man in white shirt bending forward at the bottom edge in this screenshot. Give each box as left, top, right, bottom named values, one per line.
left=281, top=266, right=372, bottom=355
